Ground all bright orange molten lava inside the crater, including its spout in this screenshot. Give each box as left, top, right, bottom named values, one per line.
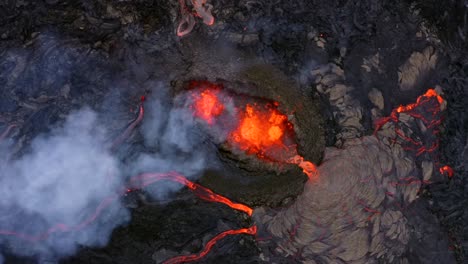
left=190, top=82, right=318, bottom=179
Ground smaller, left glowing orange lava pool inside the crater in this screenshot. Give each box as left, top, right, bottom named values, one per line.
left=193, top=89, right=224, bottom=125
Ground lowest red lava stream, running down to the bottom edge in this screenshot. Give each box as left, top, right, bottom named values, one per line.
left=163, top=226, right=257, bottom=264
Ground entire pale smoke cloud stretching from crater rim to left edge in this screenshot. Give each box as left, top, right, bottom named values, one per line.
left=0, top=50, right=212, bottom=264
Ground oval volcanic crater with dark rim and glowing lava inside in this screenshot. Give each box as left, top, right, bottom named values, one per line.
left=177, top=65, right=324, bottom=206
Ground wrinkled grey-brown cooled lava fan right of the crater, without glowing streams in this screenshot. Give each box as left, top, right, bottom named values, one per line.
left=254, top=92, right=455, bottom=263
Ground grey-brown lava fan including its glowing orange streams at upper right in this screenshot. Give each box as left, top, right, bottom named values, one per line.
left=254, top=89, right=453, bottom=263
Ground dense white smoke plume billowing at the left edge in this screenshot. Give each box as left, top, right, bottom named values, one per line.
left=0, top=108, right=129, bottom=256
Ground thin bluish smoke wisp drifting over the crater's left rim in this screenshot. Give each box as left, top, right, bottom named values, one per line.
left=128, top=85, right=208, bottom=199
